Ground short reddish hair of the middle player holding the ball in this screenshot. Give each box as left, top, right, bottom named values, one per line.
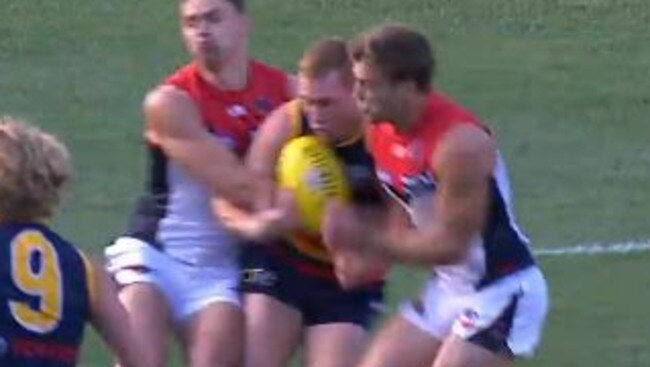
left=298, top=37, right=353, bottom=84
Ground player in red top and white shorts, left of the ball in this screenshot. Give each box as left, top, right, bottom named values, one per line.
left=106, top=0, right=291, bottom=367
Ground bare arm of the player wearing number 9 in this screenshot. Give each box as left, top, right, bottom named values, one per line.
left=86, top=259, right=154, bottom=367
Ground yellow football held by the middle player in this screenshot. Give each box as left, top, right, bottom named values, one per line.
left=276, top=136, right=350, bottom=233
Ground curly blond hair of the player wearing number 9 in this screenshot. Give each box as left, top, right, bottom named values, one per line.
left=0, top=116, right=72, bottom=222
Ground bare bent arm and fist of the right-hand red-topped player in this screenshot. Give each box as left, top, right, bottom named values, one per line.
left=323, top=125, right=496, bottom=266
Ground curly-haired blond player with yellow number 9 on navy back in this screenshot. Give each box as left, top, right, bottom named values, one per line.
left=0, top=117, right=152, bottom=367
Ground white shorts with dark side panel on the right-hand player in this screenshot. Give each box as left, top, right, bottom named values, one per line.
left=401, top=267, right=548, bottom=357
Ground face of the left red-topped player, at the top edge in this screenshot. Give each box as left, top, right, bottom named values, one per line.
left=180, top=0, right=249, bottom=67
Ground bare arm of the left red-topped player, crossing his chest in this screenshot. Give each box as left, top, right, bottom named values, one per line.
left=144, top=86, right=255, bottom=207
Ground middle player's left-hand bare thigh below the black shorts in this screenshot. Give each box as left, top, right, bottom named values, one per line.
left=244, top=293, right=302, bottom=367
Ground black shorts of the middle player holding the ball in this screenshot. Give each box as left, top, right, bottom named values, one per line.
left=241, top=244, right=384, bottom=328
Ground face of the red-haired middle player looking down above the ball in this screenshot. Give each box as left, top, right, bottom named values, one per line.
left=298, top=71, right=361, bottom=143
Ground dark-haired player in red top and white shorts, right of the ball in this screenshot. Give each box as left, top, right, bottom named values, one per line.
left=323, top=25, right=548, bottom=367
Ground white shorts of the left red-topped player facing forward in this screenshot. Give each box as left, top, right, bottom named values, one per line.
left=104, top=237, right=241, bottom=323
